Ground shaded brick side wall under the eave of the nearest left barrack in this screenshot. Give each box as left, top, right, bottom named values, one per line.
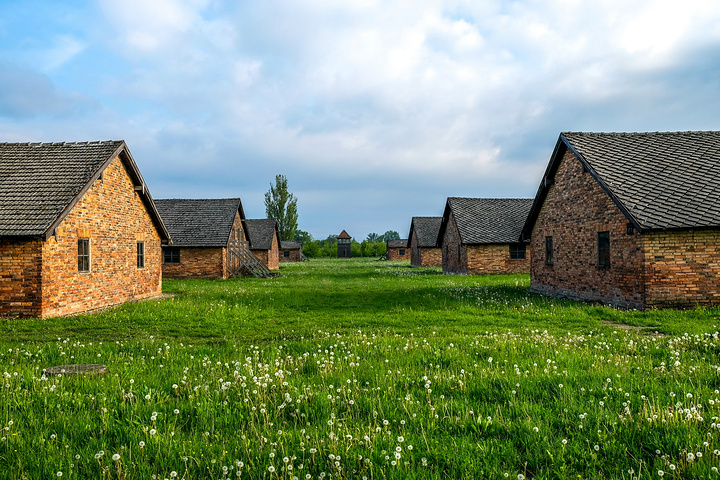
left=0, top=238, right=42, bottom=317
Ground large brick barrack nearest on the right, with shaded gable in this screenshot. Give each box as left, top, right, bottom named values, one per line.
left=523, top=132, right=720, bottom=309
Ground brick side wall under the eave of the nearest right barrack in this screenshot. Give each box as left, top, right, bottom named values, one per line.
left=643, top=230, right=720, bottom=308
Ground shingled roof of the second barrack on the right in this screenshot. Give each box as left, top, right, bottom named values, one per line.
left=443, top=197, right=533, bottom=245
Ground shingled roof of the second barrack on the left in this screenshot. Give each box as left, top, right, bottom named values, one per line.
left=155, top=198, right=243, bottom=247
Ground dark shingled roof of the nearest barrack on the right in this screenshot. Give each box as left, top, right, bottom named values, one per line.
left=560, top=132, right=720, bottom=230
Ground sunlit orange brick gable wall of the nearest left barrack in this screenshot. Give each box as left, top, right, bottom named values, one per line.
left=41, top=158, right=162, bottom=317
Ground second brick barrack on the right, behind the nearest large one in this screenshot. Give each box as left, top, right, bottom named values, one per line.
left=438, top=197, right=533, bottom=275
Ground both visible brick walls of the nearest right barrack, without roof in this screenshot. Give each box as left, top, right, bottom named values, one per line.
left=531, top=151, right=720, bottom=309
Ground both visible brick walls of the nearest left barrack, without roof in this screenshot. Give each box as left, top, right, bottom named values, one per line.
left=0, top=158, right=162, bottom=317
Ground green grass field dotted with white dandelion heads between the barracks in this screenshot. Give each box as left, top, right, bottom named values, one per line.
left=0, top=259, right=720, bottom=479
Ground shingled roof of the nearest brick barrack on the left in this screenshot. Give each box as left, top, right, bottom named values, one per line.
left=0, top=141, right=124, bottom=236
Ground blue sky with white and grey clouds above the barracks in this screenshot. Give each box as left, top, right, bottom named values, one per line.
left=0, top=0, right=720, bottom=240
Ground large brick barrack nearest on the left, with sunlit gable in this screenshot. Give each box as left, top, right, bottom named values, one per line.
left=0, top=141, right=170, bottom=317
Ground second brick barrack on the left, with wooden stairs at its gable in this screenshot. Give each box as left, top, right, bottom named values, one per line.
left=155, top=198, right=249, bottom=279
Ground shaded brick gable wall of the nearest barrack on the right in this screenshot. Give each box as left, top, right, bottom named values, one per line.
left=530, top=151, right=644, bottom=308
